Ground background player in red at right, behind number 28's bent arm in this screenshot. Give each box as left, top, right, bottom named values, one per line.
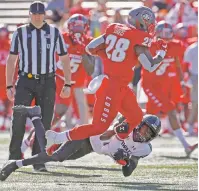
left=142, top=21, right=197, bottom=156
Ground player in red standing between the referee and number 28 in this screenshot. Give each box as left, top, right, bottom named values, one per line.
left=54, top=14, right=94, bottom=127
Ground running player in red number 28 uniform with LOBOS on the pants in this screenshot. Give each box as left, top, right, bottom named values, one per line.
left=46, top=6, right=167, bottom=157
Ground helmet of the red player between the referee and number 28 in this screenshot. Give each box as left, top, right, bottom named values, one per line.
left=67, top=14, right=89, bottom=34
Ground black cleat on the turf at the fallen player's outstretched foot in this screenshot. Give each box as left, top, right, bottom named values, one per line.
left=0, top=160, right=18, bottom=181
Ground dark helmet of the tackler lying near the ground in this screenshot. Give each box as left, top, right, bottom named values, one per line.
left=133, top=115, right=161, bottom=142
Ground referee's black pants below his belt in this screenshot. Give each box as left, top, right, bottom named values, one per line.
left=9, top=76, right=56, bottom=163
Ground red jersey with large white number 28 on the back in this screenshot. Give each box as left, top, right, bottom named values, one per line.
left=104, top=23, right=152, bottom=84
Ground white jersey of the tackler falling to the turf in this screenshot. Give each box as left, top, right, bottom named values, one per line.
left=90, top=132, right=152, bottom=158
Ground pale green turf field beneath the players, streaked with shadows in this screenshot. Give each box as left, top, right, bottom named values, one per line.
left=0, top=134, right=198, bottom=191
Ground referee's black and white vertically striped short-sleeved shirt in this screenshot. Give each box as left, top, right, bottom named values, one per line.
left=10, top=23, right=67, bottom=74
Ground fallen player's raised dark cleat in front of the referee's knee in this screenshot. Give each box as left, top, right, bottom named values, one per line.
left=12, top=105, right=41, bottom=118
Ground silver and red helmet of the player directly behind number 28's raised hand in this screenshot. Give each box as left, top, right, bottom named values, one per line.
left=155, top=21, right=173, bottom=39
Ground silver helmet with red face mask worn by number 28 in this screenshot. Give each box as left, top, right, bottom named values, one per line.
left=128, top=6, right=156, bottom=35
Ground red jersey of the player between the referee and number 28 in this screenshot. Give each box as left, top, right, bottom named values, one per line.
left=60, top=33, right=92, bottom=87
